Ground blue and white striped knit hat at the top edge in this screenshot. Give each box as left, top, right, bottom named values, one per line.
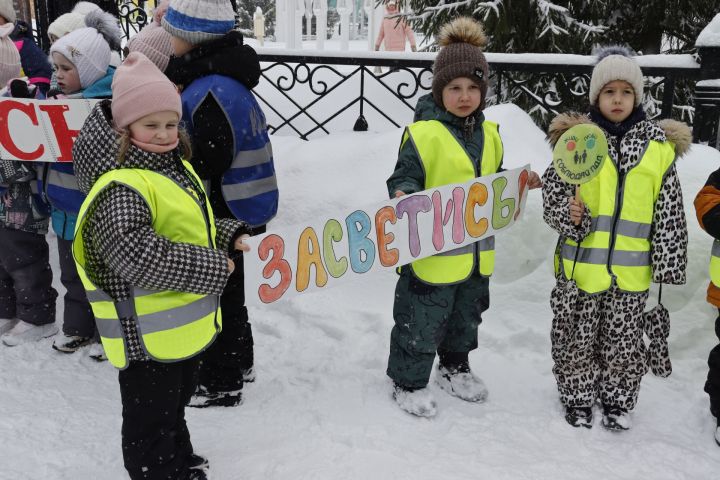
left=162, top=0, right=235, bottom=45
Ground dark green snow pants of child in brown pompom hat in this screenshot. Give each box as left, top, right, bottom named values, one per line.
left=387, top=267, right=490, bottom=388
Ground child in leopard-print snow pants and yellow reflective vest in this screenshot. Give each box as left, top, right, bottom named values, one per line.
left=543, top=47, right=691, bottom=431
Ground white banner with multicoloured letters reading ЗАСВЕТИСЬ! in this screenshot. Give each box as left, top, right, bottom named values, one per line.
left=244, top=165, right=530, bottom=305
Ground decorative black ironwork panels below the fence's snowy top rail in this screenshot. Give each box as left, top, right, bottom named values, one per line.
left=255, top=54, right=700, bottom=139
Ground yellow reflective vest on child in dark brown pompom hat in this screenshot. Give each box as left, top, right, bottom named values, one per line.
left=402, top=120, right=503, bottom=285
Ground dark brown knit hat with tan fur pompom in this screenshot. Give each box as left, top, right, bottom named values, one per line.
left=432, top=17, right=490, bottom=108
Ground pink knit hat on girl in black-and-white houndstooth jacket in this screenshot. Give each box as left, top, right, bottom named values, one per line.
left=112, top=52, right=182, bottom=129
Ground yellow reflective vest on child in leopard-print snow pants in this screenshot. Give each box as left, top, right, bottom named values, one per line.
left=559, top=141, right=675, bottom=293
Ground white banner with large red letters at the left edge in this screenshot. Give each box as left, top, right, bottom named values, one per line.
left=0, top=98, right=99, bottom=162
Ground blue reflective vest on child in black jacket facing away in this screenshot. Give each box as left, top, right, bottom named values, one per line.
left=182, top=75, right=278, bottom=226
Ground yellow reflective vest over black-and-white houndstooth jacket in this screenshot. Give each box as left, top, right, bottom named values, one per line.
left=73, top=162, right=222, bottom=369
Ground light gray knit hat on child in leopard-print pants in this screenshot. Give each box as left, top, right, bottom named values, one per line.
left=590, top=46, right=644, bottom=107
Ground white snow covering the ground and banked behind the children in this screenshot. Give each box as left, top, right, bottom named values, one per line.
left=0, top=105, right=720, bottom=480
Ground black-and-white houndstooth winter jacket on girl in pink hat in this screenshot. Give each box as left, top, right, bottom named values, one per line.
left=73, top=100, right=247, bottom=360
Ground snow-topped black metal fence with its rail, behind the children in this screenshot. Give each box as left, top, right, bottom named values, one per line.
left=255, top=49, right=720, bottom=147
